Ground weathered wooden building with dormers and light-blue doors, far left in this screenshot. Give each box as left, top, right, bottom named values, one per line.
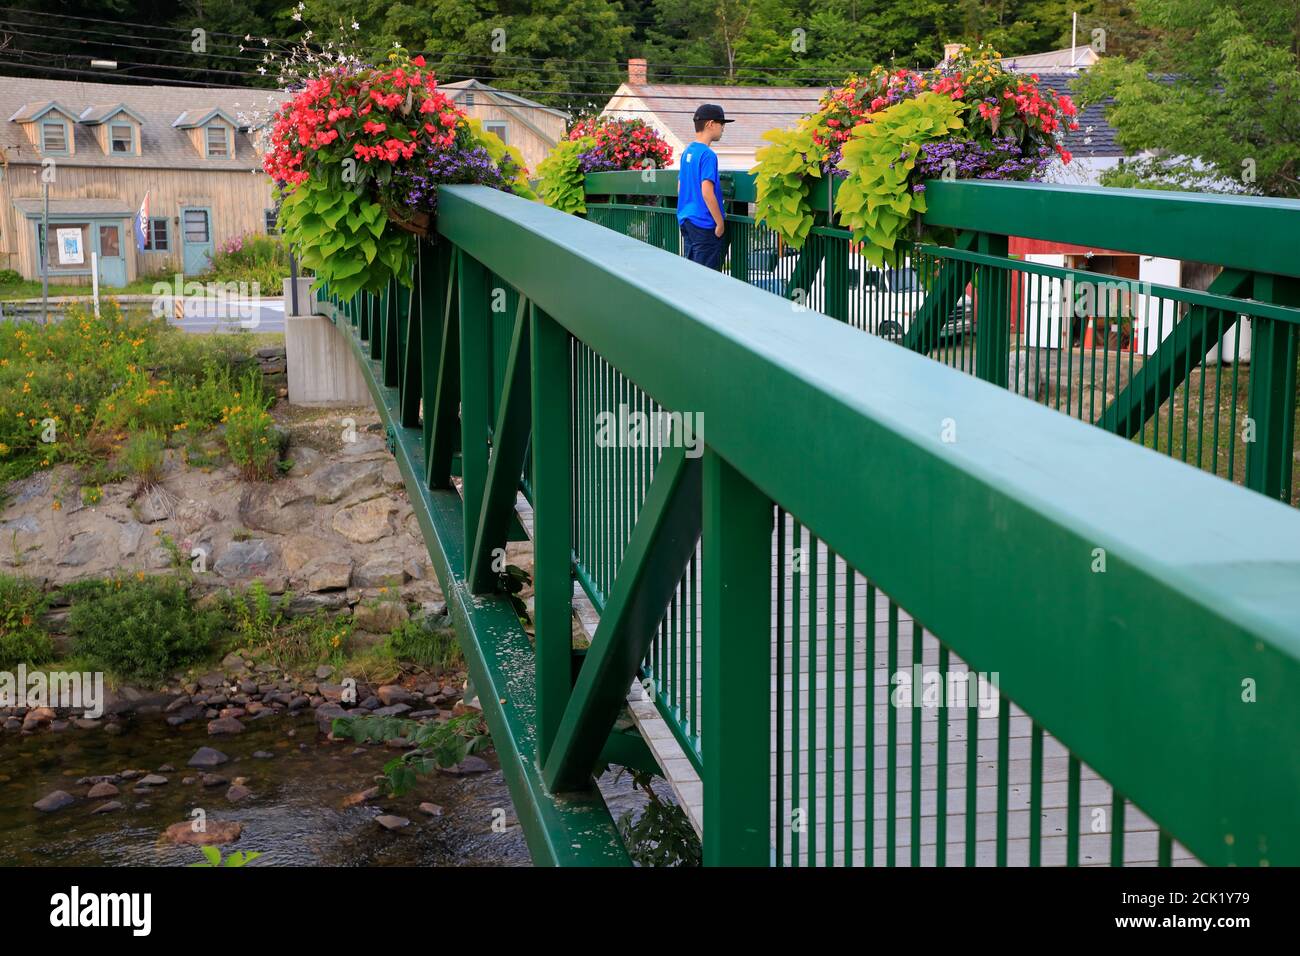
left=0, top=77, right=280, bottom=286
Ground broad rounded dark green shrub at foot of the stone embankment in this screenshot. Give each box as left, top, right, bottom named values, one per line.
left=68, top=576, right=225, bottom=683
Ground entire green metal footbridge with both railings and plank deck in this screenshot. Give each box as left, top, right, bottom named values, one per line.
left=312, top=170, right=1300, bottom=866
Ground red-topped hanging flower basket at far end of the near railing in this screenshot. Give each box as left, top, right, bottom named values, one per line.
left=263, top=49, right=537, bottom=298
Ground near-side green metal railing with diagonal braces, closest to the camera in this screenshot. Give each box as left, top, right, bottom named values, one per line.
left=312, top=185, right=1300, bottom=866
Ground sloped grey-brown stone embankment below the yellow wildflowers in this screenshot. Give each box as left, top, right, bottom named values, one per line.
left=0, top=405, right=454, bottom=643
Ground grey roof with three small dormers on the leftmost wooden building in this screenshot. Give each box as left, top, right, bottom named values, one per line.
left=0, top=77, right=285, bottom=170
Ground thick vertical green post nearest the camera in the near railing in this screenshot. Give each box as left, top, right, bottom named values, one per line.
left=702, top=449, right=780, bottom=866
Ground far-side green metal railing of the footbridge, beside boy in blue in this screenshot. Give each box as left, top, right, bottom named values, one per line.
left=588, top=170, right=1300, bottom=506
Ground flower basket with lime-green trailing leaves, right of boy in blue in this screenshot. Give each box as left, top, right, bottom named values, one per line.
left=754, top=47, right=1079, bottom=264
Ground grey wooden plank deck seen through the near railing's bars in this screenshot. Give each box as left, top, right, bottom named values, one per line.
left=517, top=496, right=1200, bottom=866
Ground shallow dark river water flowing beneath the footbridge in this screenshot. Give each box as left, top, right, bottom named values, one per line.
left=0, top=715, right=529, bottom=866
